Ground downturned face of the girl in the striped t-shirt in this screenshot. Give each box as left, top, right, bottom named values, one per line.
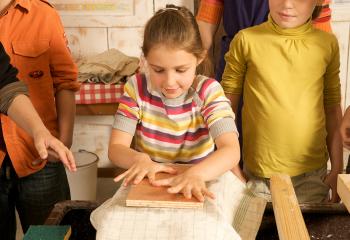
left=146, top=44, right=200, bottom=98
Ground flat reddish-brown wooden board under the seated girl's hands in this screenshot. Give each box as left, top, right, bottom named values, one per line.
left=126, top=165, right=203, bottom=208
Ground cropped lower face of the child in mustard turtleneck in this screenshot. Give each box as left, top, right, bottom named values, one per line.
left=269, top=0, right=318, bottom=28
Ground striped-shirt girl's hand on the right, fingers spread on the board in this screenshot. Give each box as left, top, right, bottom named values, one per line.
left=153, top=170, right=215, bottom=202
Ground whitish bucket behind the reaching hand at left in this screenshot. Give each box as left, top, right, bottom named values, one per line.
left=66, top=150, right=98, bottom=201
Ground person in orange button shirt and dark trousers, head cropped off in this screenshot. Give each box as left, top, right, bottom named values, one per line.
left=0, top=0, right=79, bottom=239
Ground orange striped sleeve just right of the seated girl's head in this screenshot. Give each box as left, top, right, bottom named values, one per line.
left=196, top=0, right=224, bottom=24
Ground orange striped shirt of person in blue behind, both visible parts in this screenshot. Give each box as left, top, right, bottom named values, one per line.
left=197, top=0, right=332, bottom=32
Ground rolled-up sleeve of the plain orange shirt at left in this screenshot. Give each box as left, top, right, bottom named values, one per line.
left=49, top=9, right=80, bottom=92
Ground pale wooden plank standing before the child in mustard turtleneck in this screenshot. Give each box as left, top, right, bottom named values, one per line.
left=270, top=174, right=310, bottom=240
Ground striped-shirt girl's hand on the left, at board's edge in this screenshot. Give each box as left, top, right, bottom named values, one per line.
left=114, top=156, right=176, bottom=186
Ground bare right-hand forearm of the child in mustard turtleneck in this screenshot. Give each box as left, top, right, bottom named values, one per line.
left=324, top=105, right=343, bottom=202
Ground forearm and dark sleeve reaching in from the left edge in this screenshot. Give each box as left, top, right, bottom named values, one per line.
left=0, top=42, right=76, bottom=171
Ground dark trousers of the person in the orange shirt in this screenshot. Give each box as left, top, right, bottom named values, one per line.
left=0, top=156, right=70, bottom=240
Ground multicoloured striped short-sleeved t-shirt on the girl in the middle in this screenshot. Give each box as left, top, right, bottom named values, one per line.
left=113, top=74, right=237, bottom=163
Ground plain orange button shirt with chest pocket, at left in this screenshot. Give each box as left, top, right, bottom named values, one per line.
left=0, top=0, right=80, bottom=177
